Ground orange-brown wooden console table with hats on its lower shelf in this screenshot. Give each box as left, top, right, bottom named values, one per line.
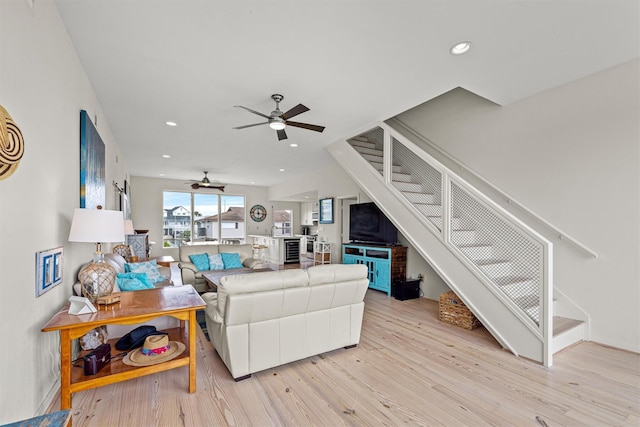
left=42, top=285, right=206, bottom=409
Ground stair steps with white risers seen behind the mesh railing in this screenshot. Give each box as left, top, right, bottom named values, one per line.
left=347, top=136, right=584, bottom=353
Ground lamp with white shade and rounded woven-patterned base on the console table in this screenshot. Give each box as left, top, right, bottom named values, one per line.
left=69, top=208, right=124, bottom=302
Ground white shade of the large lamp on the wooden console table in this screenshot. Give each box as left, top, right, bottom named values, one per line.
left=69, top=209, right=124, bottom=243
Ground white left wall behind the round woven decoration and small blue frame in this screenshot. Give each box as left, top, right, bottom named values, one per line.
left=0, top=1, right=127, bottom=424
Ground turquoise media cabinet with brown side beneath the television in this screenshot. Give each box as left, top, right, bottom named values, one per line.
left=342, top=244, right=407, bottom=296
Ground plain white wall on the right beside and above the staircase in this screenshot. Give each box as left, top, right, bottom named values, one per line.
left=397, top=60, right=640, bottom=352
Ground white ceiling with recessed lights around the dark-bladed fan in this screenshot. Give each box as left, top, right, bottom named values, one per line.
left=55, top=0, right=640, bottom=194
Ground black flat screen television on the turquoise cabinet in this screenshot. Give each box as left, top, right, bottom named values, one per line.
left=349, top=203, right=398, bottom=246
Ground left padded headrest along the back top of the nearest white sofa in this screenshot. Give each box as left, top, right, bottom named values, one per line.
left=215, top=269, right=309, bottom=322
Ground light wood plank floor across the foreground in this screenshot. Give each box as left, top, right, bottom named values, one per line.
left=52, top=290, right=640, bottom=427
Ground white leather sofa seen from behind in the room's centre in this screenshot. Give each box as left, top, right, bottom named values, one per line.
left=202, top=264, right=369, bottom=381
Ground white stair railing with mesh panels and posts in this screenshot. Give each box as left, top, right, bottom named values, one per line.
left=348, top=123, right=553, bottom=366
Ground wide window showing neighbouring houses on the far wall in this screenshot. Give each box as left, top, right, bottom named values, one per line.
left=162, top=191, right=246, bottom=248
